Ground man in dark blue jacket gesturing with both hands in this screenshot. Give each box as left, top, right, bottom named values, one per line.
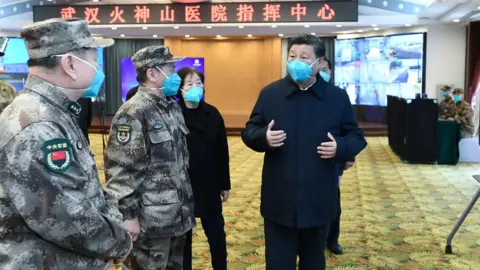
left=242, top=35, right=367, bottom=270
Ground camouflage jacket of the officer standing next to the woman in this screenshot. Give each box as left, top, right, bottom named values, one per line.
left=105, top=87, right=195, bottom=236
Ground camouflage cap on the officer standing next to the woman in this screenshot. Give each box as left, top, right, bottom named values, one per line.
left=132, top=46, right=185, bottom=69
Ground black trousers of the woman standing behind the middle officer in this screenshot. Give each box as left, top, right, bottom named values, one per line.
left=183, top=211, right=227, bottom=270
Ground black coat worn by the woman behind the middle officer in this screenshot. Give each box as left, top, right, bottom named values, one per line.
left=179, top=100, right=230, bottom=217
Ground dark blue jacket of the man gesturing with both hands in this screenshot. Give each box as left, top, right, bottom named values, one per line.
left=242, top=76, right=367, bottom=228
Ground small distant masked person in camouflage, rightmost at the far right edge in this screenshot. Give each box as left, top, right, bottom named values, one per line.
left=453, top=88, right=474, bottom=138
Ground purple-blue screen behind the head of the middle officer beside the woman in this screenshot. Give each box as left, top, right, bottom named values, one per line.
left=121, top=57, right=205, bottom=103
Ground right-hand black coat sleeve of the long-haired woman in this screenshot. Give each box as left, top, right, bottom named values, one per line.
left=217, top=113, right=231, bottom=191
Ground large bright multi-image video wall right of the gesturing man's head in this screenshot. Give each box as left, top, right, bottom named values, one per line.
left=334, top=33, right=425, bottom=106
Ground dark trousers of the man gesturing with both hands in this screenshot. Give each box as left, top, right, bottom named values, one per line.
left=264, top=219, right=329, bottom=270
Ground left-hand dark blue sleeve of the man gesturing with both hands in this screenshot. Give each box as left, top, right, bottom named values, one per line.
left=242, top=91, right=270, bottom=152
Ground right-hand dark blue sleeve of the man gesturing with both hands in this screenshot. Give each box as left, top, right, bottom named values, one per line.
left=335, top=92, right=367, bottom=163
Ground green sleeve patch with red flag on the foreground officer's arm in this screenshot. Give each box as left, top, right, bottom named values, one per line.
left=42, top=138, right=72, bottom=173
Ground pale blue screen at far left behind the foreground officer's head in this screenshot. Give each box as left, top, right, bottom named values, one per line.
left=0, top=38, right=103, bottom=91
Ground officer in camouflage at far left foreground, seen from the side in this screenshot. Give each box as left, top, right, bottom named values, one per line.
left=0, top=19, right=132, bottom=270
